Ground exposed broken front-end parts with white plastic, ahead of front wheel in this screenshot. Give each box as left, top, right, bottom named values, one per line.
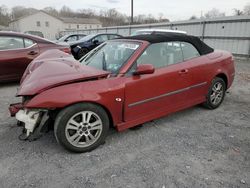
left=9, top=104, right=48, bottom=140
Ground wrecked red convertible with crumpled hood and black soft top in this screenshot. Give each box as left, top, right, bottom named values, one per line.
left=10, top=33, right=235, bottom=152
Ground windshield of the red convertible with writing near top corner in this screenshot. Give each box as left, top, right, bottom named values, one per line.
left=80, top=41, right=140, bottom=74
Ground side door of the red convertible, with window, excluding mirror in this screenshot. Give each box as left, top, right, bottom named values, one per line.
left=124, top=42, right=190, bottom=121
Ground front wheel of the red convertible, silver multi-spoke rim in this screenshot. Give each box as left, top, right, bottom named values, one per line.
left=54, top=103, right=110, bottom=153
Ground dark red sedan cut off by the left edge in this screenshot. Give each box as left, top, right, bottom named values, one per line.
left=0, top=32, right=71, bottom=82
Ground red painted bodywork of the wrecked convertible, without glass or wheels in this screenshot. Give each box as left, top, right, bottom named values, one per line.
left=10, top=41, right=234, bottom=131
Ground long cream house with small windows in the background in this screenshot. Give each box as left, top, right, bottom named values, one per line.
left=9, top=10, right=102, bottom=40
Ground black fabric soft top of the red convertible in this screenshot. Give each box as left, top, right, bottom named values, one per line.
left=122, top=33, right=214, bottom=55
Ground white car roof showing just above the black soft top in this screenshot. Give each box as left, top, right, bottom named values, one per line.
left=131, top=29, right=187, bottom=36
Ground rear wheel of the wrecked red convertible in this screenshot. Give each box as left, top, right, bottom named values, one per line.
left=203, top=77, right=226, bottom=109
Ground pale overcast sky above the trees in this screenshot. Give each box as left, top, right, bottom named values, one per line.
left=0, top=0, right=250, bottom=21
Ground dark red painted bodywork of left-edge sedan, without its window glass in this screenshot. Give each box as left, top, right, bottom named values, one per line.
left=0, top=32, right=70, bottom=82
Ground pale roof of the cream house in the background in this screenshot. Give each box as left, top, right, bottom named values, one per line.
left=10, top=10, right=102, bottom=24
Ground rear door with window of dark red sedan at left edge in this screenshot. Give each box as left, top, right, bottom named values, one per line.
left=0, top=36, right=39, bottom=81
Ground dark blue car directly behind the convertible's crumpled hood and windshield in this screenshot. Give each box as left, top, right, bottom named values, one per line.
left=69, top=33, right=122, bottom=59
